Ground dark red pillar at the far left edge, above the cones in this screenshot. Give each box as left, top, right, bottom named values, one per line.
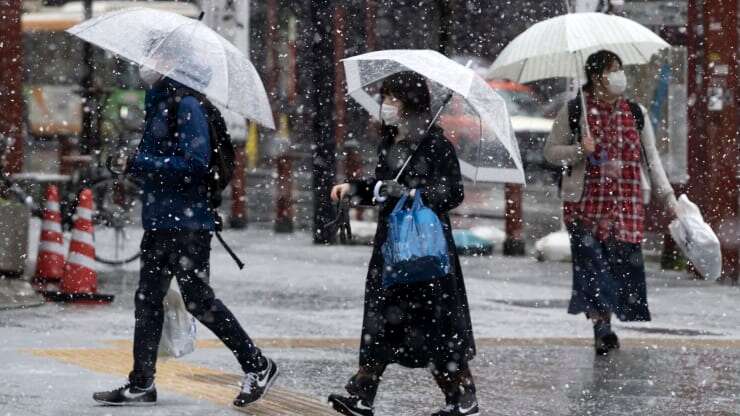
left=0, top=0, right=23, bottom=174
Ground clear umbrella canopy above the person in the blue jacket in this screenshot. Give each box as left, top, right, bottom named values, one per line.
left=67, top=8, right=275, bottom=129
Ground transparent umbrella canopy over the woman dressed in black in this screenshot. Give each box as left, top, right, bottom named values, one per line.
left=343, top=49, right=524, bottom=183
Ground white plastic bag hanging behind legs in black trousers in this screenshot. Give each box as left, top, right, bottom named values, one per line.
left=158, top=283, right=196, bottom=358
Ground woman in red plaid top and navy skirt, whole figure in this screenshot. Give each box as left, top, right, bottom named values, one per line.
left=545, top=51, right=676, bottom=355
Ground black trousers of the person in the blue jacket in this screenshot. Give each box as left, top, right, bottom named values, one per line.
left=131, top=230, right=266, bottom=385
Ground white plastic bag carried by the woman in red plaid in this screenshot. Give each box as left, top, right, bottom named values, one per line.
left=668, top=195, right=722, bottom=279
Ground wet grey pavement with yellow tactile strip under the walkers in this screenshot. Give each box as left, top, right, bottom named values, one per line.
left=0, top=229, right=740, bottom=416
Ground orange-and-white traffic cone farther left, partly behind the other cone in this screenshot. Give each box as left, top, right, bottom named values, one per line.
left=33, top=185, right=67, bottom=291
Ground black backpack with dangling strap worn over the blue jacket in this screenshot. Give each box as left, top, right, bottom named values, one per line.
left=167, top=89, right=244, bottom=269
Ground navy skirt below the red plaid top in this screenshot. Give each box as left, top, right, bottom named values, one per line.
left=568, top=224, right=650, bottom=321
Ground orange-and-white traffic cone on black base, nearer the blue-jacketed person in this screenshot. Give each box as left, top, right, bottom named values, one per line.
left=46, top=188, right=114, bottom=303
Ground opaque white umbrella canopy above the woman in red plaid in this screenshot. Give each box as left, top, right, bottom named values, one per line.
left=488, top=13, right=670, bottom=83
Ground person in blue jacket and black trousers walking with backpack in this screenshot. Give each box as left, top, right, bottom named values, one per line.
left=93, top=67, right=278, bottom=407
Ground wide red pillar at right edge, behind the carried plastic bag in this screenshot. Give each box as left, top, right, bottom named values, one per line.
left=688, top=0, right=740, bottom=282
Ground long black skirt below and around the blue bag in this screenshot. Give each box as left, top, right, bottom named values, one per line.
left=360, top=237, right=475, bottom=370
